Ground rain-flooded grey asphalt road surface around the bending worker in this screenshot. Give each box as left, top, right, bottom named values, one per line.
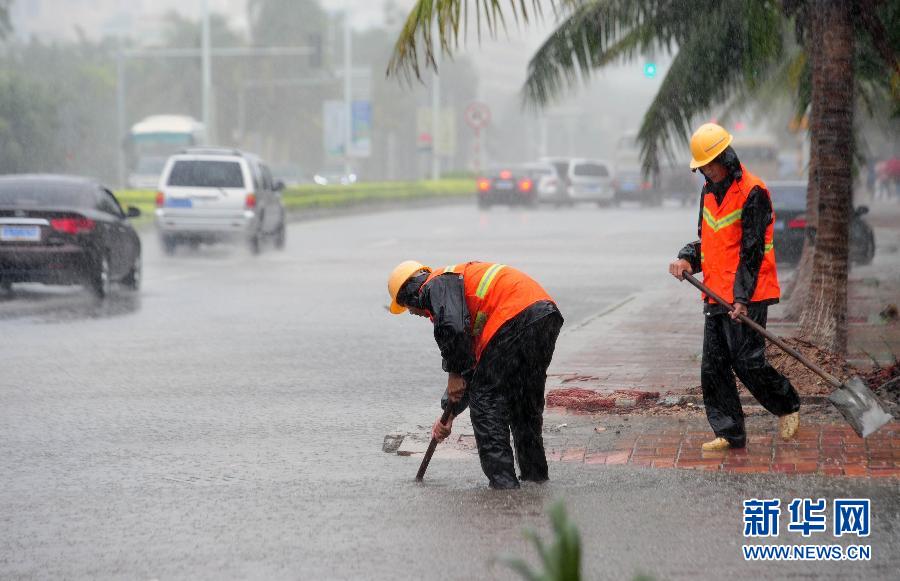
left=0, top=206, right=900, bottom=579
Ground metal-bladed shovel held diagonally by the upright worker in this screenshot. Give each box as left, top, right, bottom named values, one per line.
left=684, top=272, right=893, bottom=438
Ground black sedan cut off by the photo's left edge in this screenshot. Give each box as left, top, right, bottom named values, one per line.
left=0, top=175, right=141, bottom=298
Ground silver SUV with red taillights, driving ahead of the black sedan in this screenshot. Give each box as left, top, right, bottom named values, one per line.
left=156, top=148, right=285, bottom=254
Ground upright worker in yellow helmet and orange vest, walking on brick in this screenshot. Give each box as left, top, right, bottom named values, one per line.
left=669, top=123, right=800, bottom=450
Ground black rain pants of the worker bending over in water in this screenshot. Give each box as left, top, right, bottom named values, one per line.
left=467, top=312, right=563, bottom=488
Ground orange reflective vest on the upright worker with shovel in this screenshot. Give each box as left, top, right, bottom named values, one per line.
left=700, top=165, right=781, bottom=303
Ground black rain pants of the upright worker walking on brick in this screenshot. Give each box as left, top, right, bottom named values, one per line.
left=700, top=304, right=800, bottom=448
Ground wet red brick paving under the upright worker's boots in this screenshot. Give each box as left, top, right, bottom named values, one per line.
left=548, top=422, right=900, bottom=478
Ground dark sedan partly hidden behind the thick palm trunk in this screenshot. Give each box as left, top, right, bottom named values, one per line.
left=768, top=182, right=875, bottom=264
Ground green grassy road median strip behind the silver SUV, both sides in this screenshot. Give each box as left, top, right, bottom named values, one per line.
left=116, top=179, right=475, bottom=223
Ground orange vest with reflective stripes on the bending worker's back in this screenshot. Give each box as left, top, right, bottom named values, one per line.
left=422, top=262, right=553, bottom=361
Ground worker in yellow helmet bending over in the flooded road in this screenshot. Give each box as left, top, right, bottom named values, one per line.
left=388, top=260, right=563, bottom=489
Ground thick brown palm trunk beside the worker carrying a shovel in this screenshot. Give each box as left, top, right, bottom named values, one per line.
left=800, top=0, right=854, bottom=353
